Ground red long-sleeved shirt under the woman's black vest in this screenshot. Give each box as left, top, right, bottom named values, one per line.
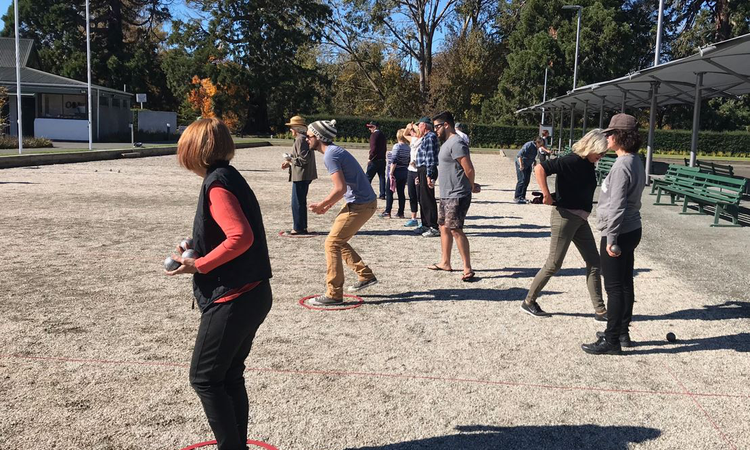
left=195, top=183, right=260, bottom=303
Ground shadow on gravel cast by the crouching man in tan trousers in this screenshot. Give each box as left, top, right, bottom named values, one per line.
left=360, top=286, right=561, bottom=305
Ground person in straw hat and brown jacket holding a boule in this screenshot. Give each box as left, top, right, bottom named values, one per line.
left=281, top=116, right=318, bottom=234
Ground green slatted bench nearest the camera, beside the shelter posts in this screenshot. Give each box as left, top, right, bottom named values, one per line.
left=654, top=167, right=747, bottom=227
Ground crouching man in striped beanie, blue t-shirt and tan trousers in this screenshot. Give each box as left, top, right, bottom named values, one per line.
left=307, top=120, right=378, bottom=306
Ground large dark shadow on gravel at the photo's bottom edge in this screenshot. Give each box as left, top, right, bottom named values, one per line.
left=347, top=425, right=661, bottom=450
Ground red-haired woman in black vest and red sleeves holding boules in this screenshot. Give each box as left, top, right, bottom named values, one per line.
left=167, top=119, right=272, bottom=450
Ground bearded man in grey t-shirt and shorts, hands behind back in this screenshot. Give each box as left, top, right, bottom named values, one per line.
left=428, top=111, right=480, bottom=281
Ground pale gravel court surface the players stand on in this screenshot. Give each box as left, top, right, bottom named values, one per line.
left=0, top=147, right=750, bottom=449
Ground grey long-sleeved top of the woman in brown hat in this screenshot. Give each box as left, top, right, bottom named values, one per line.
left=596, top=153, right=646, bottom=245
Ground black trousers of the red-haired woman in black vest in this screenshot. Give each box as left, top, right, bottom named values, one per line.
left=190, top=280, right=272, bottom=450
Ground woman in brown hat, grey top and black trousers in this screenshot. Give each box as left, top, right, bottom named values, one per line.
left=581, top=114, right=646, bottom=355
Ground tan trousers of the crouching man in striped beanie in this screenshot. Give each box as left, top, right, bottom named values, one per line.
left=325, top=200, right=378, bottom=299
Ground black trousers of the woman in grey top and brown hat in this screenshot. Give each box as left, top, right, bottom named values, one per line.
left=599, top=228, right=642, bottom=343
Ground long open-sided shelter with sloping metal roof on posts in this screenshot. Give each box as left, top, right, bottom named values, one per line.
left=516, top=34, right=750, bottom=180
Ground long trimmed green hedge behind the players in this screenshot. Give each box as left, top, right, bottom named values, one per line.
left=296, top=115, right=750, bottom=157
